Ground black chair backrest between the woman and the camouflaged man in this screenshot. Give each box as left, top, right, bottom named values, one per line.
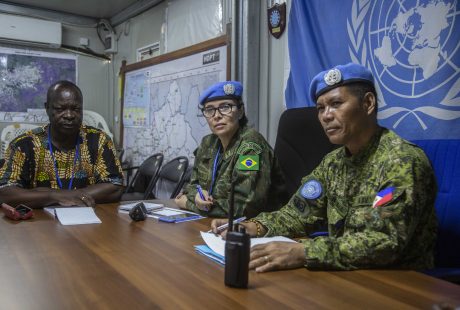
left=275, top=107, right=337, bottom=196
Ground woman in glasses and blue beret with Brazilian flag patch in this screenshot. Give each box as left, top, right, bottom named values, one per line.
left=176, top=81, right=288, bottom=218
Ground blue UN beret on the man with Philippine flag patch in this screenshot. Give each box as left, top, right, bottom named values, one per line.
left=310, top=63, right=374, bottom=103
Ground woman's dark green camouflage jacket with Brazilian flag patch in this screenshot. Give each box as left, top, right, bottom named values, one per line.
left=184, top=126, right=288, bottom=218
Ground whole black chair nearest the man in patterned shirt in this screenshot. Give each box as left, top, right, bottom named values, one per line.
left=121, top=153, right=163, bottom=201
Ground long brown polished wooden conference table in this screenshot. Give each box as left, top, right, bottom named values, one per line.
left=0, top=201, right=460, bottom=309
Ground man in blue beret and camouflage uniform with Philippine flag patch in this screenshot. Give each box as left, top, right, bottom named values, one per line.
left=212, top=64, right=436, bottom=272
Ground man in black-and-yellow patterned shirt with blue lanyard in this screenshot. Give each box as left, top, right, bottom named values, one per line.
left=0, top=81, right=123, bottom=208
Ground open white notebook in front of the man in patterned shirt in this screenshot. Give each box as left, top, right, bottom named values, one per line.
left=44, top=207, right=101, bottom=225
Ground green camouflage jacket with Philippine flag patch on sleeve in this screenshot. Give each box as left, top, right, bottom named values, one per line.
left=257, top=129, right=437, bottom=270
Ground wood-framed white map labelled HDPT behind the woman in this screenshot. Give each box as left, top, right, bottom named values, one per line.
left=120, top=36, right=230, bottom=165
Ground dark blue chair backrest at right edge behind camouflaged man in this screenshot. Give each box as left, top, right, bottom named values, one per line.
left=413, top=140, right=460, bottom=268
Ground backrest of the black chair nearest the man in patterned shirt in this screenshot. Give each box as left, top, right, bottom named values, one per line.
left=125, top=153, right=163, bottom=196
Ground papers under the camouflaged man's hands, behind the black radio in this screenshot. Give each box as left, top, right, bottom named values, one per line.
left=195, top=231, right=295, bottom=265
